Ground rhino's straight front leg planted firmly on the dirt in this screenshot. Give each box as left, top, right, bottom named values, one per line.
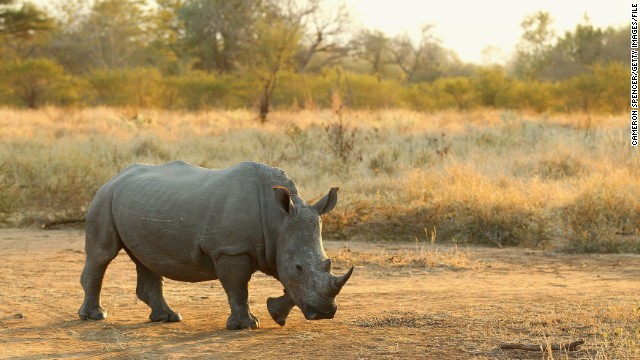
left=215, top=255, right=260, bottom=330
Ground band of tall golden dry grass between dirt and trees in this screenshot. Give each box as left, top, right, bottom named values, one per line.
left=0, top=108, right=640, bottom=252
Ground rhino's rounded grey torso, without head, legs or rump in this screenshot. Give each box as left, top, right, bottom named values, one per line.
left=92, top=162, right=296, bottom=281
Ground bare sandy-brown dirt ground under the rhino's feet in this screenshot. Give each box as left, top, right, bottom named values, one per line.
left=0, top=229, right=640, bottom=359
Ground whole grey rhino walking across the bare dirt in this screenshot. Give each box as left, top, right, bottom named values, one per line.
left=78, top=161, right=353, bottom=329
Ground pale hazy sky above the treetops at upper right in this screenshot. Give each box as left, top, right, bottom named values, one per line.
left=342, top=0, right=631, bottom=63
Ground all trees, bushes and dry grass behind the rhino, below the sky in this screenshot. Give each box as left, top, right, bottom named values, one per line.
left=0, top=0, right=640, bottom=253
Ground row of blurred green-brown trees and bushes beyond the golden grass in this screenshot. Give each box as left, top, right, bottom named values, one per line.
left=0, top=0, right=629, bottom=115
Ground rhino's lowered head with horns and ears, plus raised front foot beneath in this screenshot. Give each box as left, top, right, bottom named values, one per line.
left=267, top=186, right=353, bottom=325
